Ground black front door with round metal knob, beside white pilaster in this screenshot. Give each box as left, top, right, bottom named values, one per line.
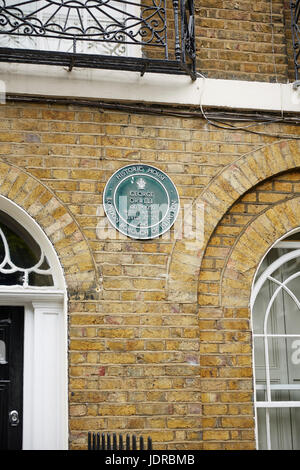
left=0, top=306, right=24, bottom=450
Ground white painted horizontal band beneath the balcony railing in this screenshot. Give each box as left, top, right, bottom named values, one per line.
left=0, top=63, right=300, bottom=112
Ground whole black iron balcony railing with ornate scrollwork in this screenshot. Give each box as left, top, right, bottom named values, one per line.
left=0, top=0, right=196, bottom=79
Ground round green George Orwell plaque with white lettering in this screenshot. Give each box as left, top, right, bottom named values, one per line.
left=103, top=164, right=179, bottom=240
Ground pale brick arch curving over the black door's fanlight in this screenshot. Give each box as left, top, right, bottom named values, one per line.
left=0, top=162, right=98, bottom=297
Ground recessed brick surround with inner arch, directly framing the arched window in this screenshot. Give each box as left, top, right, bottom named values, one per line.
left=198, top=177, right=300, bottom=449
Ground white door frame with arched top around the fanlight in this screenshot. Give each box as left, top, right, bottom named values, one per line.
left=0, top=196, right=68, bottom=450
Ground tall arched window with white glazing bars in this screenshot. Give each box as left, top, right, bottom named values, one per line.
left=251, top=232, right=300, bottom=450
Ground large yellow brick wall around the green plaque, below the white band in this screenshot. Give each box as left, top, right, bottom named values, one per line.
left=0, top=102, right=300, bottom=449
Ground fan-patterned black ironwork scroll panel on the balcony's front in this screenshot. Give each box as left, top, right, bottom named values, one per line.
left=0, top=0, right=166, bottom=46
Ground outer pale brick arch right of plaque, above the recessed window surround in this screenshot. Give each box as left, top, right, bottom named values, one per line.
left=167, top=140, right=300, bottom=302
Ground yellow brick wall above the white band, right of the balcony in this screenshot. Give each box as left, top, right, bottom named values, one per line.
left=195, top=0, right=295, bottom=83
